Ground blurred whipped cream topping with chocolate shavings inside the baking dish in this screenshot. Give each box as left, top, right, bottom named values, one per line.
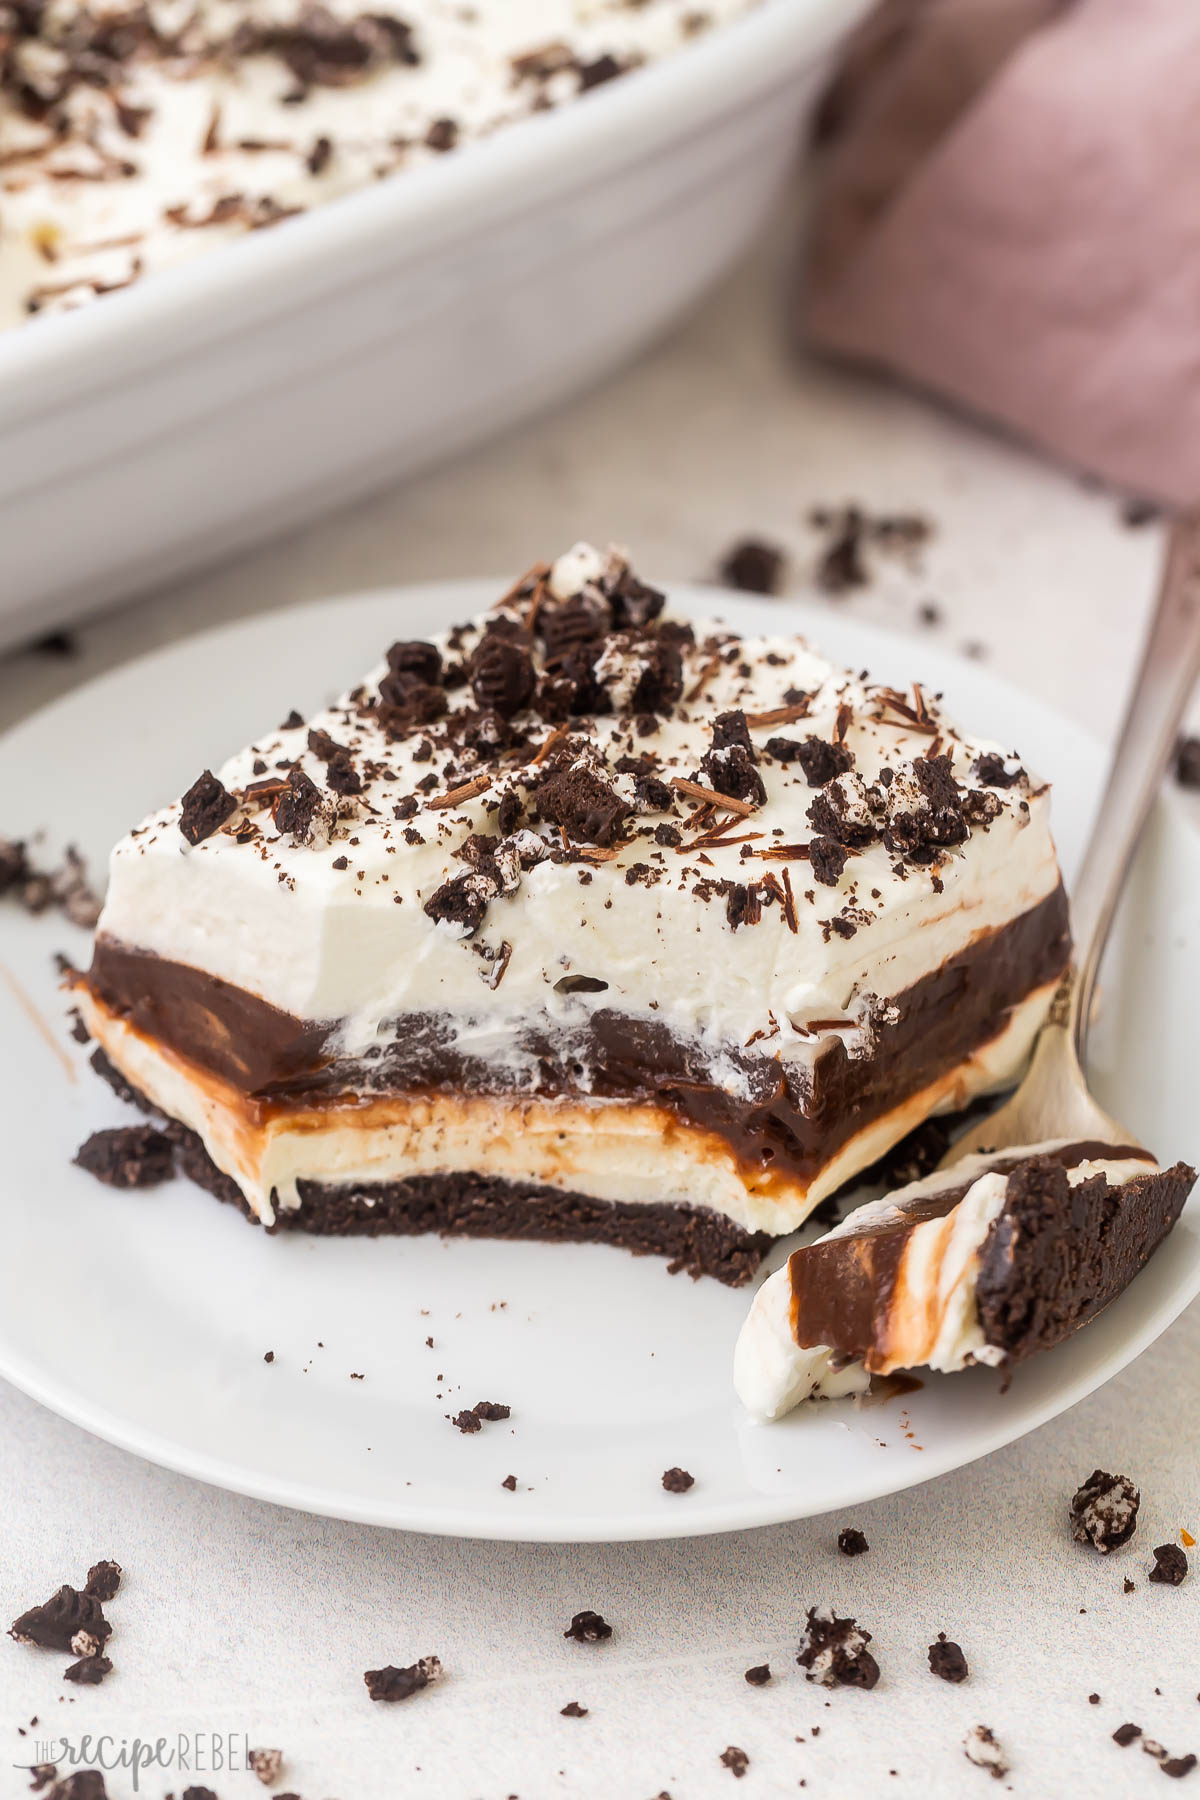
left=0, top=0, right=754, bottom=328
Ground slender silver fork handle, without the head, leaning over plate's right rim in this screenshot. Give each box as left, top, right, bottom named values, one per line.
left=1067, top=513, right=1200, bottom=1064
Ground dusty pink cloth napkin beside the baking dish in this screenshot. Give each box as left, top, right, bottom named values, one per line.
left=804, top=0, right=1200, bottom=506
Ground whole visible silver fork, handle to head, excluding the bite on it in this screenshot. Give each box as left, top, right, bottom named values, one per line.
left=941, top=515, right=1200, bottom=1168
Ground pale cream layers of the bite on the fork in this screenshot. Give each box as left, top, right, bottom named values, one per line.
left=734, top=1138, right=1159, bottom=1418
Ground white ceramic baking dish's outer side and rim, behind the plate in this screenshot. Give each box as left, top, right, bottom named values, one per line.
left=0, top=0, right=865, bottom=644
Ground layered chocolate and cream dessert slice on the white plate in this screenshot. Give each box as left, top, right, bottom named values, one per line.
left=81, top=545, right=1069, bottom=1282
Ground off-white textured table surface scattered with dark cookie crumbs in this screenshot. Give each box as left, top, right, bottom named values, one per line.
left=0, top=225, right=1200, bottom=1800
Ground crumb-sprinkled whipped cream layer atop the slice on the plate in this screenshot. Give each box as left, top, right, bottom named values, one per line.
left=99, top=532, right=1058, bottom=1098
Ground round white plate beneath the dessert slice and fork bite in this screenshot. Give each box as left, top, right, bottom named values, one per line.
left=0, top=583, right=1200, bottom=1541
